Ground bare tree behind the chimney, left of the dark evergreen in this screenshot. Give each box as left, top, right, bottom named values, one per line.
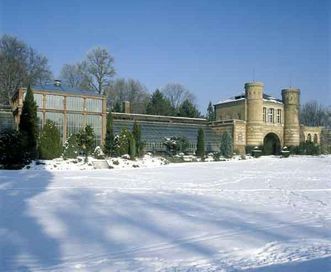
left=106, top=78, right=150, bottom=113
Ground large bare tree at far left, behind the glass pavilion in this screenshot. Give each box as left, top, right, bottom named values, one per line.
left=0, top=35, right=52, bottom=104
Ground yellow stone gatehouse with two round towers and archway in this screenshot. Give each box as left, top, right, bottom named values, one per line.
left=211, top=82, right=322, bottom=154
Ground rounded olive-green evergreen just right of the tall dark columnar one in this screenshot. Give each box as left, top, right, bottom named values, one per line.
left=38, top=120, right=62, bottom=160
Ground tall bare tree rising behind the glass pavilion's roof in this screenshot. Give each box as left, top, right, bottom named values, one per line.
left=82, top=47, right=115, bottom=94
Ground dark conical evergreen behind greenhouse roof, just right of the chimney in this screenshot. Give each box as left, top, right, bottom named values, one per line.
left=146, top=90, right=174, bottom=115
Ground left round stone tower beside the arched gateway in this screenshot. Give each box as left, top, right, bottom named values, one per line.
left=245, top=82, right=264, bottom=146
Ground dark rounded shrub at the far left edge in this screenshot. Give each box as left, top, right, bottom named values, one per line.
left=0, top=129, right=24, bottom=169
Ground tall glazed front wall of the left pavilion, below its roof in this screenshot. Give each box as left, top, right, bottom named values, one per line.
left=12, top=88, right=106, bottom=145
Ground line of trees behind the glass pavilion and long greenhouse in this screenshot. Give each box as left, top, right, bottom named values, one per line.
left=0, top=34, right=217, bottom=117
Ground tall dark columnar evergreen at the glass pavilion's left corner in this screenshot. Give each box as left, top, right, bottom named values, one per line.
left=19, top=85, right=38, bottom=161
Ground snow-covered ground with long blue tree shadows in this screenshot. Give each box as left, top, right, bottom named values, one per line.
left=0, top=156, right=331, bottom=272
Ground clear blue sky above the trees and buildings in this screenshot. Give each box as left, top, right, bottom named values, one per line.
left=0, top=0, right=331, bottom=113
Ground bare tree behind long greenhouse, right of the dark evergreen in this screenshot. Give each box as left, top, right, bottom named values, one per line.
left=161, top=83, right=195, bottom=110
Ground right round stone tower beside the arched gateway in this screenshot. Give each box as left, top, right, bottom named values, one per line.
left=282, top=88, right=300, bottom=146
